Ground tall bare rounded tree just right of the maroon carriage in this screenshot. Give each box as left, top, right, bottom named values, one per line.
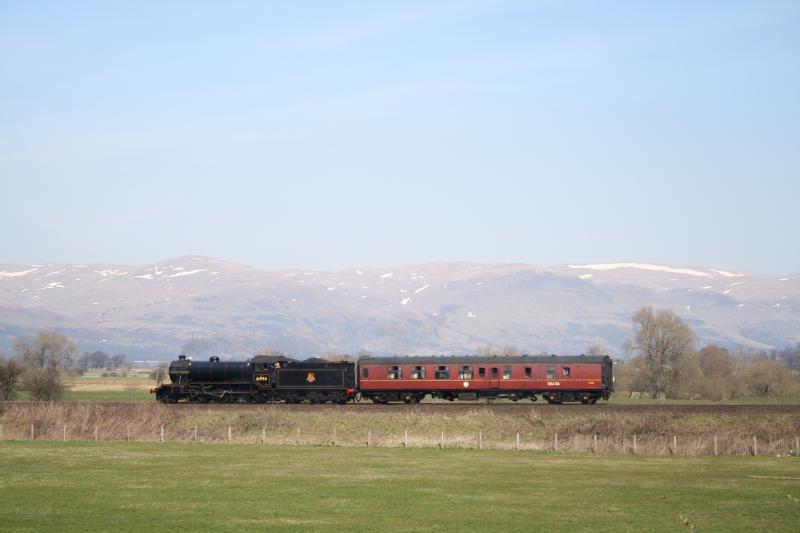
left=629, top=307, right=694, bottom=398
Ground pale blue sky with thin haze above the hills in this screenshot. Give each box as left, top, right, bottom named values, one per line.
left=0, top=1, right=800, bottom=273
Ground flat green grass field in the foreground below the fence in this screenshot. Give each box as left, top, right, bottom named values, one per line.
left=0, top=441, right=800, bottom=532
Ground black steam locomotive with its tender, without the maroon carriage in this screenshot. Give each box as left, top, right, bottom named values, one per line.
left=150, top=355, right=356, bottom=404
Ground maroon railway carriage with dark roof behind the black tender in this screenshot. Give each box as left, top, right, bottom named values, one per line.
left=358, top=355, right=614, bottom=404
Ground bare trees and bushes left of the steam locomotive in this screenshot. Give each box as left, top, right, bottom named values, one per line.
left=0, top=329, right=127, bottom=401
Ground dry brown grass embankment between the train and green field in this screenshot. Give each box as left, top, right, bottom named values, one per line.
left=0, top=402, right=800, bottom=455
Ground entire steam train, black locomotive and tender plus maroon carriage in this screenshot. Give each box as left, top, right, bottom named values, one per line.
left=151, top=355, right=614, bottom=404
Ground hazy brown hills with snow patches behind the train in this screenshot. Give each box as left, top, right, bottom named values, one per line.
left=0, top=256, right=800, bottom=359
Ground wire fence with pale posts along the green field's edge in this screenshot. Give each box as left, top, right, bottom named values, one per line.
left=0, top=424, right=800, bottom=457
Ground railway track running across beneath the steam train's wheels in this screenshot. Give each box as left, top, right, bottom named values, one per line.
left=0, top=400, right=800, bottom=416
